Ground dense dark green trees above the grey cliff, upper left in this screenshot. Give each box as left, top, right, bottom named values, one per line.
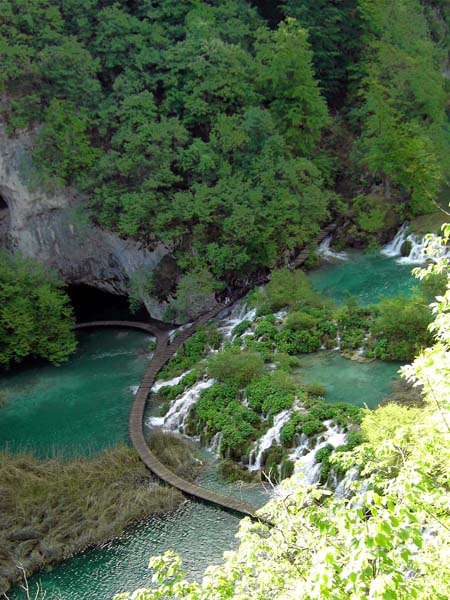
left=0, top=0, right=331, bottom=288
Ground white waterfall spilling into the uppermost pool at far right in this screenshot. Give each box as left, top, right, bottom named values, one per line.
left=381, top=223, right=450, bottom=265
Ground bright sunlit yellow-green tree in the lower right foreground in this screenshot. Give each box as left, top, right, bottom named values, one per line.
left=116, top=226, right=450, bottom=600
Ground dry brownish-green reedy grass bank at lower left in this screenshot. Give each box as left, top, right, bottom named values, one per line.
left=0, top=442, right=190, bottom=594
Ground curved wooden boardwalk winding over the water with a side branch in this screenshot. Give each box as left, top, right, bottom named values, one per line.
left=74, top=225, right=335, bottom=520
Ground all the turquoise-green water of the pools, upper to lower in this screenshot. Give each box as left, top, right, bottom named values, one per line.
left=0, top=229, right=426, bottom=600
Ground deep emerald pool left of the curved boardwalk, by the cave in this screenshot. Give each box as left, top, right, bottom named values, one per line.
left=0, top=329, right=151, bottom=457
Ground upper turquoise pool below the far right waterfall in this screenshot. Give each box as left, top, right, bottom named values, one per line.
left=309, top=251, right=417, bottom=305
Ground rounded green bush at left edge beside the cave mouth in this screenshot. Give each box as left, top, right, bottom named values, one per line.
left=0, top=253, right=76, bottom=367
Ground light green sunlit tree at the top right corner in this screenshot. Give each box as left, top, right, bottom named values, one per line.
left=352, top=0, right=450, bottom=214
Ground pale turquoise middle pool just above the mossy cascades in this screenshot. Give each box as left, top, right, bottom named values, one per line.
left=295, top=352, right=400, bottom=408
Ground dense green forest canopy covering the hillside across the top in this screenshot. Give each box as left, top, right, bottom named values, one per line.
left=0, top=0, right=448, bottom=296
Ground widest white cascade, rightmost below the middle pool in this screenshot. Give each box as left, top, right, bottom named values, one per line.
left=289, top=420, right=347, bottom=484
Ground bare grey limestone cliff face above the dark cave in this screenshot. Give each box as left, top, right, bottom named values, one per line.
left=0, top=126, right=176, bottom=319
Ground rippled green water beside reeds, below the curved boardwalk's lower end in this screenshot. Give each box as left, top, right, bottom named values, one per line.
left=10, top=451, right=268, bottom=600
